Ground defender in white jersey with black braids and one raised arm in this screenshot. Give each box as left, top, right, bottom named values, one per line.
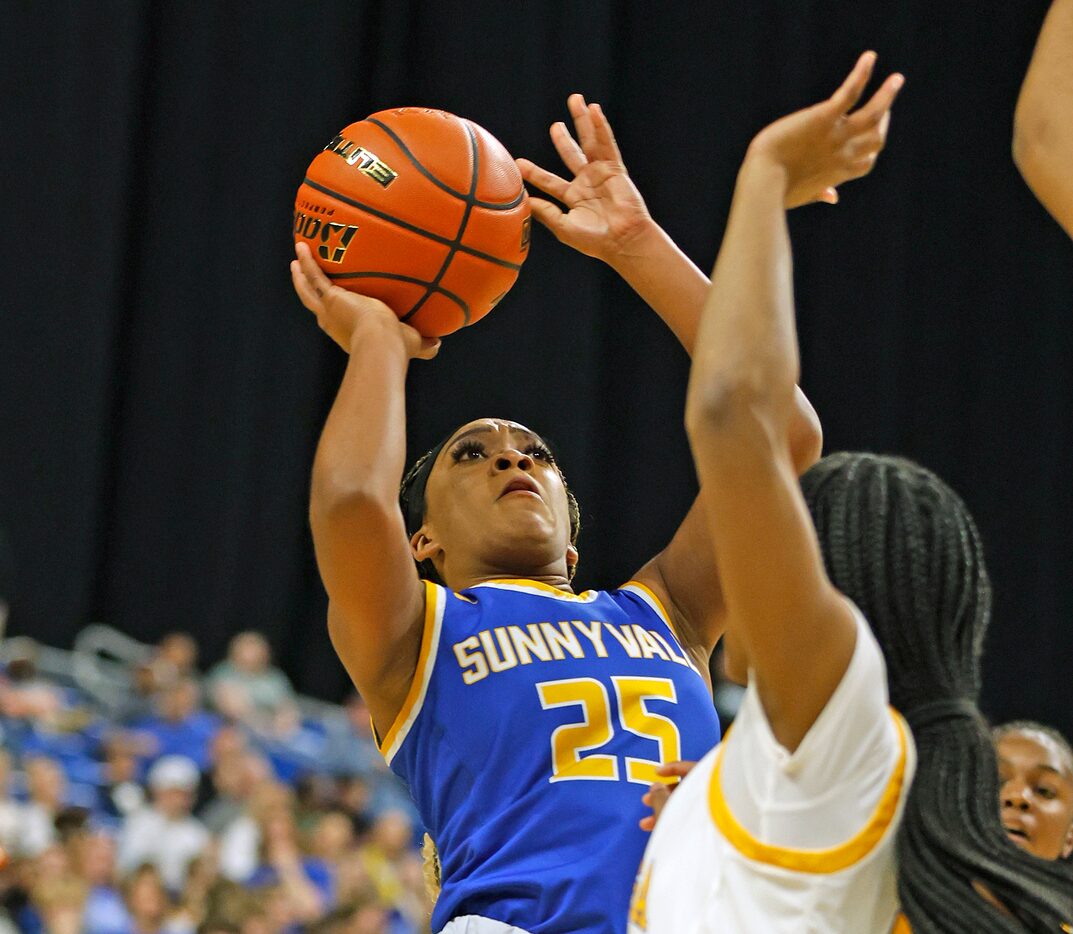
left=631, top=53, right=1073, bottom=934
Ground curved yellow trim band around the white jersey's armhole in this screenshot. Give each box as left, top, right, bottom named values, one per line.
left=708, top=707, right=909, bottom=873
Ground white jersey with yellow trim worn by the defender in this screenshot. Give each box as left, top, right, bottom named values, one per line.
left=630, top=609, right=915, bottom=934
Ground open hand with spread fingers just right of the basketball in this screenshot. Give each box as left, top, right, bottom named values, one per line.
left=517, top=94, right=651, bottom=265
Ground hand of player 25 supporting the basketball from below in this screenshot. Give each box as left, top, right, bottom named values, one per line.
left=291, top=242, right=440, bottom=360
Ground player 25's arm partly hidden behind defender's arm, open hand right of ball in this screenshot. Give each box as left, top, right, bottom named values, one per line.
left=518, top=94, right=822, bottom=660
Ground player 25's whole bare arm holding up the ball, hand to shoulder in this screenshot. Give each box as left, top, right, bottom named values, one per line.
left=291, top=244, right=439, bottom=735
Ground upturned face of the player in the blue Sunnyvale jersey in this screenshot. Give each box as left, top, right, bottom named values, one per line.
left=414, top=419, right=576, bottom=578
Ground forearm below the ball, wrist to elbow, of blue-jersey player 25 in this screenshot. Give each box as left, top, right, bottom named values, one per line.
left=311, top=319, right=409, bottom=507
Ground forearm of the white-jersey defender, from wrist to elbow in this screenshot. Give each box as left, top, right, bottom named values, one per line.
left=687, top=158, right=798, bottom=430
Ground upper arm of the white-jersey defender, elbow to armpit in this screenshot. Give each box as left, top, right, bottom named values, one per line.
left=694, top=410, right=855, bottom=749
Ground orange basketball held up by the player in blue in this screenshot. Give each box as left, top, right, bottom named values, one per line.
left=294, top=107, right=531, bottom=337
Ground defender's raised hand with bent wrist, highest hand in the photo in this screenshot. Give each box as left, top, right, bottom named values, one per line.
left=743, top=52, right=906, bottom=208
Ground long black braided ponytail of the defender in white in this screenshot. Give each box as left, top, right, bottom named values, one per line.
left=802, top=453, right=1073, bottom=934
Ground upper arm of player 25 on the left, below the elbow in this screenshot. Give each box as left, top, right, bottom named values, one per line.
left=310, top=497, right=425, bottom=725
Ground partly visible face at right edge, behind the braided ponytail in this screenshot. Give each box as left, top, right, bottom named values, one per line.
left=996, top=732, right=1073, bottom=860
